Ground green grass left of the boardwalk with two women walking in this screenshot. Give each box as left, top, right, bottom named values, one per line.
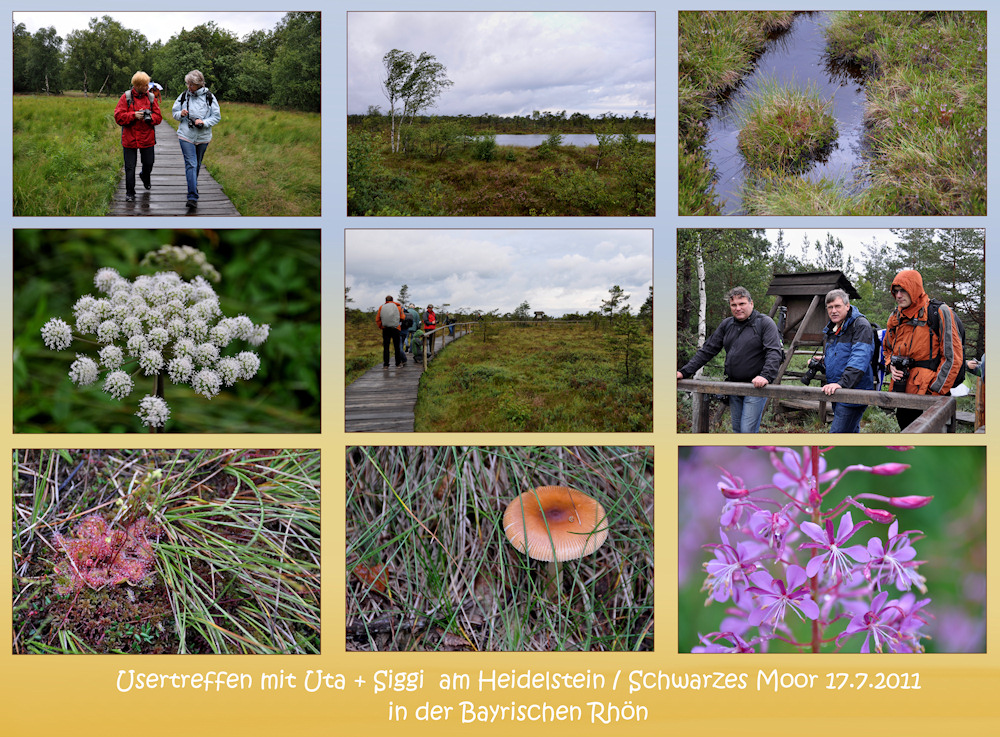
left=12, top=95, right=123, bottom=217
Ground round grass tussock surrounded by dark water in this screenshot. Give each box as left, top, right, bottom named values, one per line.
left=738, top=79, right=837, bottom=174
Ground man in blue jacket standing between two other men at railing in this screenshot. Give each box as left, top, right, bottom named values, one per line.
left=823, top=289, right=875, bottom=432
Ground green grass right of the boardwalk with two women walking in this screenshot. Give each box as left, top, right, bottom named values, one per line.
left=163, top=102, right=322, bottom=217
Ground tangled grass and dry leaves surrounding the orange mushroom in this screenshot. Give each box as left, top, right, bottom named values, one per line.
left=346, top=446, right=654, bottom=651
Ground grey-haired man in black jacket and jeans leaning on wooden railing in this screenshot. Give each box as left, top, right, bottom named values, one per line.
left=677, top=287, right=782, bottom=432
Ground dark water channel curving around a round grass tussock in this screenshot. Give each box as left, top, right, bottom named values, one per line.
left=706, top=12, right=867, bottom=215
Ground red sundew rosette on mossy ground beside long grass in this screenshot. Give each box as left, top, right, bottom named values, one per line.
left=53, top=514, right=160, bottom=594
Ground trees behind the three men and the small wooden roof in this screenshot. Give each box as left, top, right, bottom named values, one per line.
left=677, top=228, right=986, bottom=363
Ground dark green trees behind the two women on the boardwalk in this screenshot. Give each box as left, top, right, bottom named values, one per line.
left=13, top=12, right=322, bottom=112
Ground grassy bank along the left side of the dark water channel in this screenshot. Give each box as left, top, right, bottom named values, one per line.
left=678, top=11, right=795, bottom=215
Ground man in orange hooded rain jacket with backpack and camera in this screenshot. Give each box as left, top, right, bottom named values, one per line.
left=882, top=269, right=965, bottom=430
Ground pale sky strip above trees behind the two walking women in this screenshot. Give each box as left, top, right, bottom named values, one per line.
left=14, top=11, right=285, bottom=43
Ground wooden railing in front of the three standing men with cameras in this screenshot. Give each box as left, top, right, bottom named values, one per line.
left=677, top=379, right=957, bottom=433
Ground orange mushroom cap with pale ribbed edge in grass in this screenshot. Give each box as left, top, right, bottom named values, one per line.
left=503, top=486, right=608, bottom=561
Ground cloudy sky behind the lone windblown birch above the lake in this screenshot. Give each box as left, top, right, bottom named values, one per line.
left=347, top=12, right=656, bottom=117
